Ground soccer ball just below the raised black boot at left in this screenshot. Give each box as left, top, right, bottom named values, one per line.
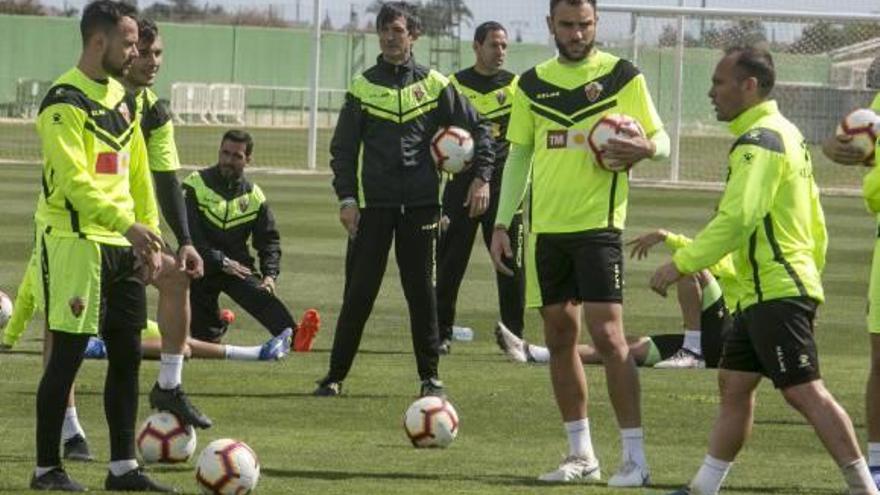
left=137, top=411, right=196, bottom=464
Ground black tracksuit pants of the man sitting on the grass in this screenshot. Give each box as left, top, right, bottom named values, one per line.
left=189, top=272, right=296, bottom=343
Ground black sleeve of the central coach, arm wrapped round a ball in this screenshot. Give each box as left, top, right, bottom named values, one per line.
left=437, top=83, right=495, bottom=183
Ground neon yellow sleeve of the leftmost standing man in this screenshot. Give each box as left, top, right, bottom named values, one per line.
left=38, top=103, right=135, bottom=234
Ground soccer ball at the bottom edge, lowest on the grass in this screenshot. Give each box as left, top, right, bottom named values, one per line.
left=196, top=438, right=260, bottom=495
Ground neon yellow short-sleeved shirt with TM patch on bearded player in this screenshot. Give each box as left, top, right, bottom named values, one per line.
left=502, top=50, right=663, bottom=233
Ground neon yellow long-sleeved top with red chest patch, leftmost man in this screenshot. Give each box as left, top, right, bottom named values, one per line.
left=37, top=68, right=159, bottom=246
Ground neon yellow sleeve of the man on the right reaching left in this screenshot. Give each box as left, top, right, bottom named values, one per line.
left=672, top=144, right=782, bottom=274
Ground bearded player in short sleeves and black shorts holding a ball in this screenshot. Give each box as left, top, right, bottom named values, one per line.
left=491, top=0, right=669, bottom=487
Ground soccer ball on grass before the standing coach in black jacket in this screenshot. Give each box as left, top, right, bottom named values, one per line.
left=403, top=396, right=458, bottom=448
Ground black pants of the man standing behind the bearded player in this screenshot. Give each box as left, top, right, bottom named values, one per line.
left=437, top=175, right=525, bottom=340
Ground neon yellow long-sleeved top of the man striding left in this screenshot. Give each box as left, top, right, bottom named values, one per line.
left=673, top=101, right=828, bottom=309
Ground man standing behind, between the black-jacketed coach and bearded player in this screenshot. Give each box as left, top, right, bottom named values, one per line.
left=437, top=21, right=525, bottom=353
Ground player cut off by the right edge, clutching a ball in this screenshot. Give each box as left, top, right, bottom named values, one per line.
left=822, top=76, right=880, bottom=488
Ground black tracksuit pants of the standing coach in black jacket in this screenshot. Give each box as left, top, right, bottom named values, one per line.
left=327, top=206, right=439, bottom=382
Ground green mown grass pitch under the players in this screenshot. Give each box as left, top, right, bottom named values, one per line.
left=0, top=164, right=876, bottom=495
